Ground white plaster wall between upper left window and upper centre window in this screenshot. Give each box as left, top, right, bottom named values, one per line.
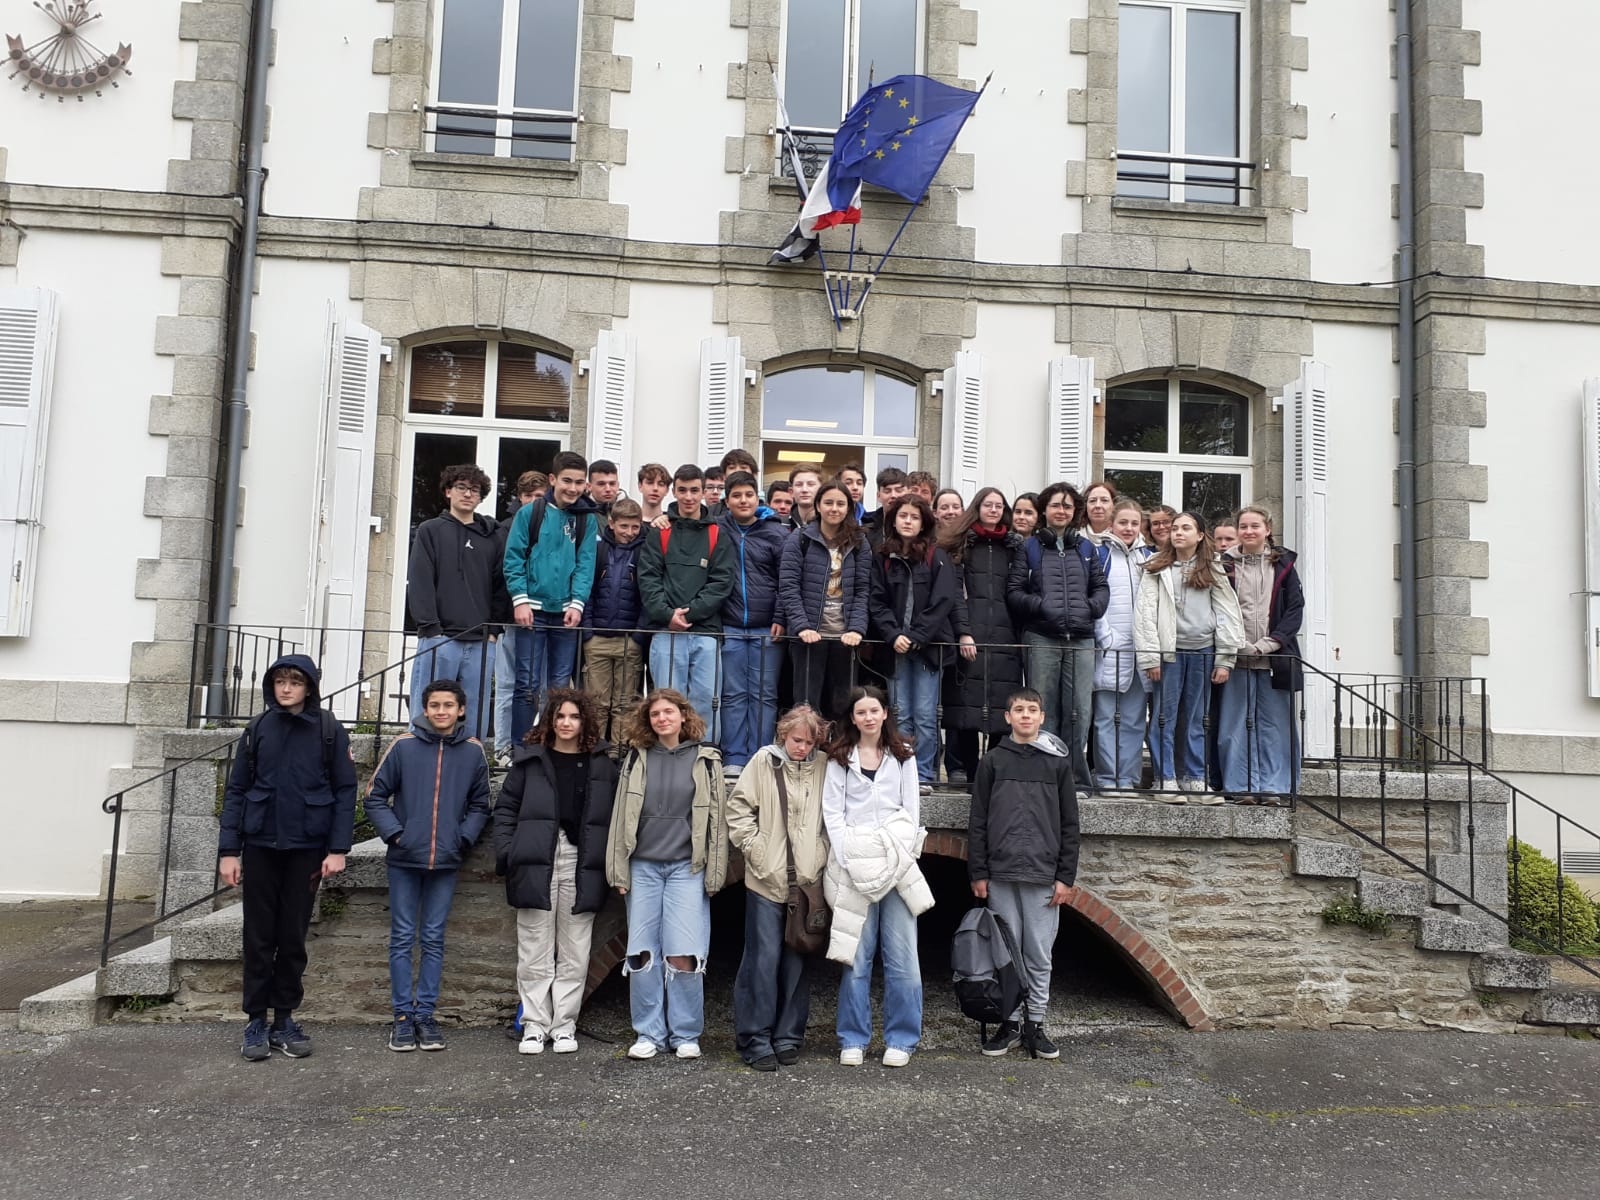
left=611, top=0, right=742, bottom=245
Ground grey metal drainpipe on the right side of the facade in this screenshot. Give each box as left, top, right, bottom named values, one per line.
left=1395, top=0, right=1418, bottom=677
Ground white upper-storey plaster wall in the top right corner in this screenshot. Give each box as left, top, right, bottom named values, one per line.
left=1461, top=0, right=1600, bottom=283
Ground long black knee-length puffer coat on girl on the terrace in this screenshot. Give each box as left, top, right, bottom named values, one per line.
left=942, top=530, right=1027, bottom=733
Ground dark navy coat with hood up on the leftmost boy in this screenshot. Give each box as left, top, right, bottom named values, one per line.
left=218, top=654, right=357, bottom=858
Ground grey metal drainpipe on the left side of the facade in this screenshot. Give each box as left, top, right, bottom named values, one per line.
left=205, top=0, right=272, bottom=717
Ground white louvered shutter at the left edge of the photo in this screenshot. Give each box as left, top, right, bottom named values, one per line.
left=0, top=288, right=58, bottom=637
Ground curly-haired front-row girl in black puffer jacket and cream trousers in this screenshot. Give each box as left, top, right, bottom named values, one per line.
left=494, top=688, right=618, bottom=1054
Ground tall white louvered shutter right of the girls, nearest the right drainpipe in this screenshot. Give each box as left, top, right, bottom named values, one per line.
left=1280, top=362, right=1333, bottom=757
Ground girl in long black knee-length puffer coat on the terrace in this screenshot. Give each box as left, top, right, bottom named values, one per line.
left=939, top=488, right=1026, bottom=784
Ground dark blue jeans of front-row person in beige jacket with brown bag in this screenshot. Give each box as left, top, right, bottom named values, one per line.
left=733, top=891, right=811, bottom=1062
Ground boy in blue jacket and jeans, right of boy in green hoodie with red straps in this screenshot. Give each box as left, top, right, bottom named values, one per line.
left=717, top=470, right=789, bottom=776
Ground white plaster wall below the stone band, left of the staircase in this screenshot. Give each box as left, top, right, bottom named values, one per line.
left=0, top=720, right=133, bottom=896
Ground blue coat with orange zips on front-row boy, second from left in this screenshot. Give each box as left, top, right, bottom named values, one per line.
left=366, top=717, right=490, bottom=870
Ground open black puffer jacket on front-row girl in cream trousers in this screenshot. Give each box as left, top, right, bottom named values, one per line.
left=494, top=742, right=618, bottom=912
